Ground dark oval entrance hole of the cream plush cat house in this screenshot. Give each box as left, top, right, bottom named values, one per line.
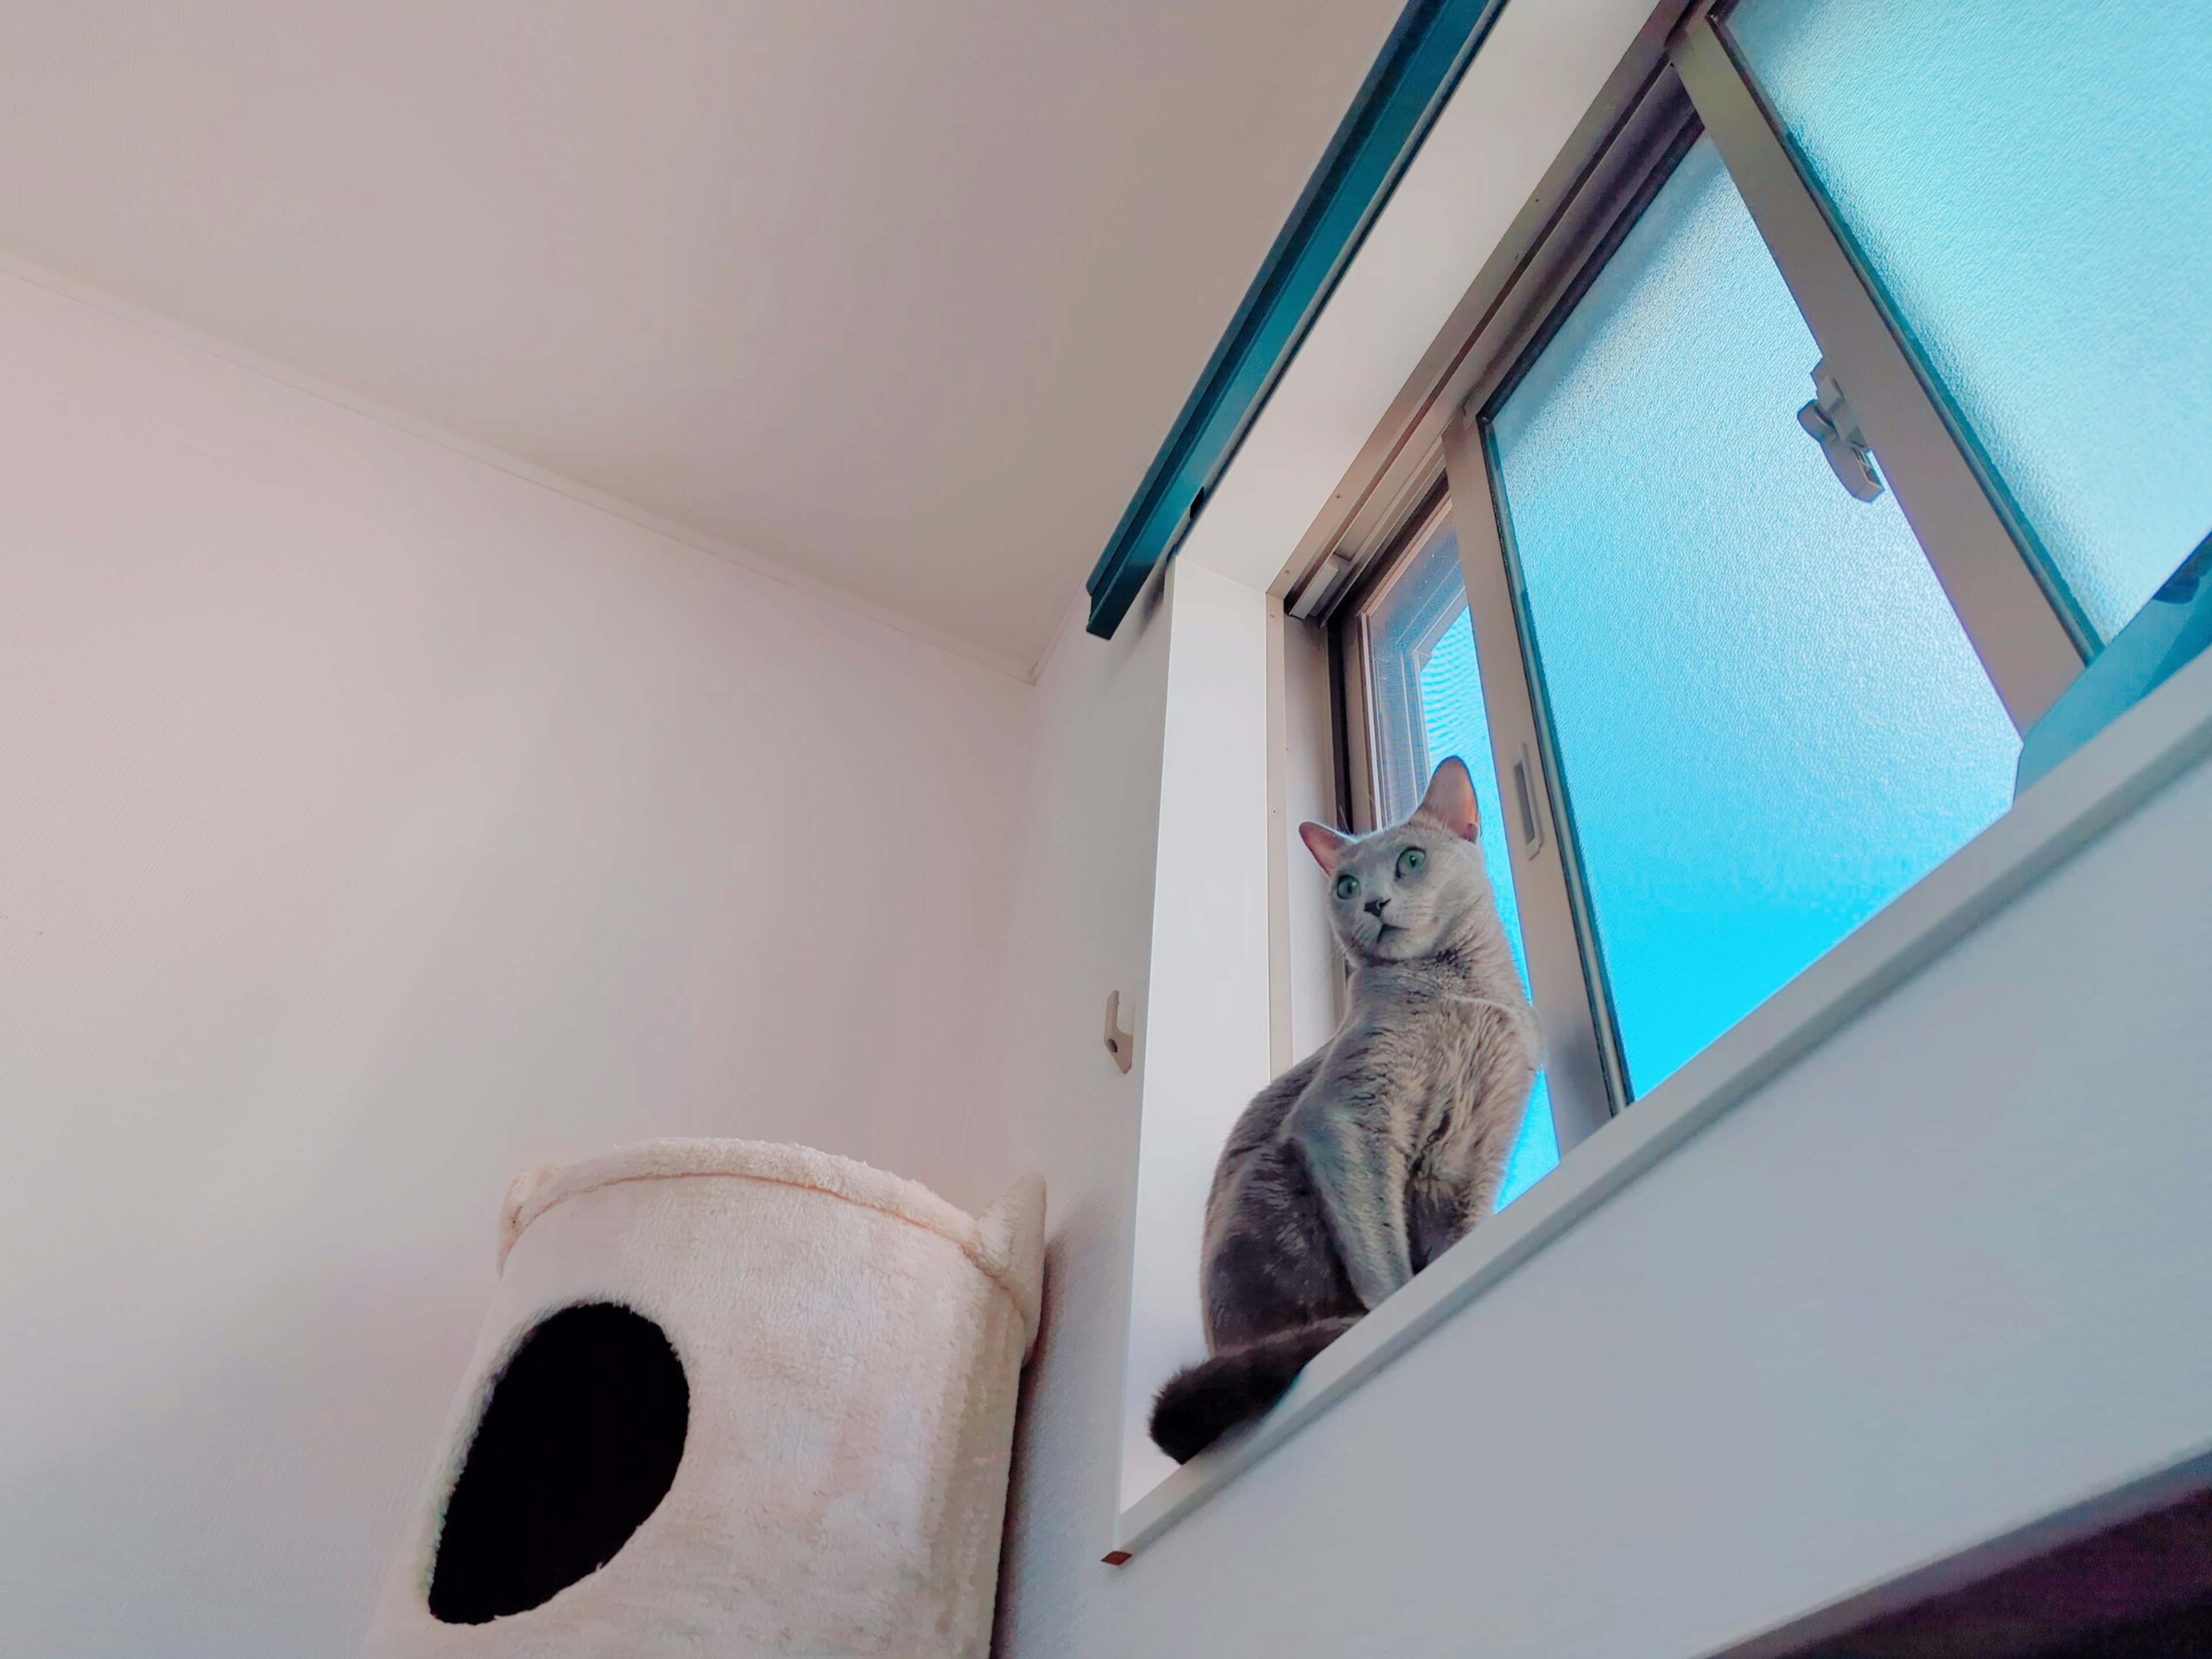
left=429, top=1303, right=690, bottom=1624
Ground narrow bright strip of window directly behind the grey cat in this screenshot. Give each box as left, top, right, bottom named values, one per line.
left=1369, top=524, right=1559, bottom=1210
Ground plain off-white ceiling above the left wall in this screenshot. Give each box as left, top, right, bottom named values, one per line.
left=0, top=0, right=1398, bottom=664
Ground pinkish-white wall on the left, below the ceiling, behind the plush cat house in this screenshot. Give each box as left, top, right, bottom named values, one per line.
left=0, top=279, right=1031, bottom=1659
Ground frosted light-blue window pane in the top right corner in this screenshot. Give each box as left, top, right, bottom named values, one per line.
left=1728, top=0, right=2212, bottom=639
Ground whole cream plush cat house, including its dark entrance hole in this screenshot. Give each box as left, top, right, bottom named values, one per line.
left=365, top=1141, right=1044, bottom=1659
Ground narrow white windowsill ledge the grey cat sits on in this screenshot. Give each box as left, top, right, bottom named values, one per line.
left=1106, top=653, right=2212, bottom=1564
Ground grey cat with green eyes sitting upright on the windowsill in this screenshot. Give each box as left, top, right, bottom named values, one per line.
left=1153, top=759, right=1537, bottom=1462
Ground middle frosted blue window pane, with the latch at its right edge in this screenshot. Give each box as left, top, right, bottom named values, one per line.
left=1491, top=139, right=2020, bottom=1093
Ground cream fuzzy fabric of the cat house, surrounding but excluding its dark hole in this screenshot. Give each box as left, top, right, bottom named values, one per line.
left=363, top=1141, right=1044, bottom=1659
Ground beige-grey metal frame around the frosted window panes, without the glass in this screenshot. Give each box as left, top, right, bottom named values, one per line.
left=1285, top=0, right=2093, bottom=1119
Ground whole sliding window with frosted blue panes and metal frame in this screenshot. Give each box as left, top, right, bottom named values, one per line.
left=1292, top=0, right=2212, bottom=1141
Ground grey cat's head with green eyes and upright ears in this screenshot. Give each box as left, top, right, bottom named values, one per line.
left=1298, top=756, right=1493, bottom=962
